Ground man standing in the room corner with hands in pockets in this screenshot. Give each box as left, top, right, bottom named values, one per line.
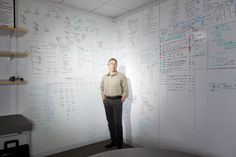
left=100, top=58, right=128, bottom=149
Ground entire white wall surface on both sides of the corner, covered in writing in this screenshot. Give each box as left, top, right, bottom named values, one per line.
left=0, top=0, right=236, bottom=157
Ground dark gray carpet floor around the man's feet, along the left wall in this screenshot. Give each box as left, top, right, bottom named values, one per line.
left=47, top=140, right=132, bottom=157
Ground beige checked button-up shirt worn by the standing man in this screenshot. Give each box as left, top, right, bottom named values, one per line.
left=100, top=71, right=128, bottom=98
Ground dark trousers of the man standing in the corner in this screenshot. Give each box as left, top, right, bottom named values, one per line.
left=103, top=98, right=123, bottom=146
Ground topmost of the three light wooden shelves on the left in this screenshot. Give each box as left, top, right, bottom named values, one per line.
left=0, top=26, right=28, bottom=37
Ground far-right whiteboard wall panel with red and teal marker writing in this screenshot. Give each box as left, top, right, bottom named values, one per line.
left=160, top=0, right=236, bottom=157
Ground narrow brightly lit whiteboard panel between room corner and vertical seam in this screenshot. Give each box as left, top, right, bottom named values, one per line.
left=113, top=3, right=160, bottom=147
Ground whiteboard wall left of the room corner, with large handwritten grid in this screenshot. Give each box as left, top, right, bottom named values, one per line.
left=18, top=0, right=113, bottom=156
